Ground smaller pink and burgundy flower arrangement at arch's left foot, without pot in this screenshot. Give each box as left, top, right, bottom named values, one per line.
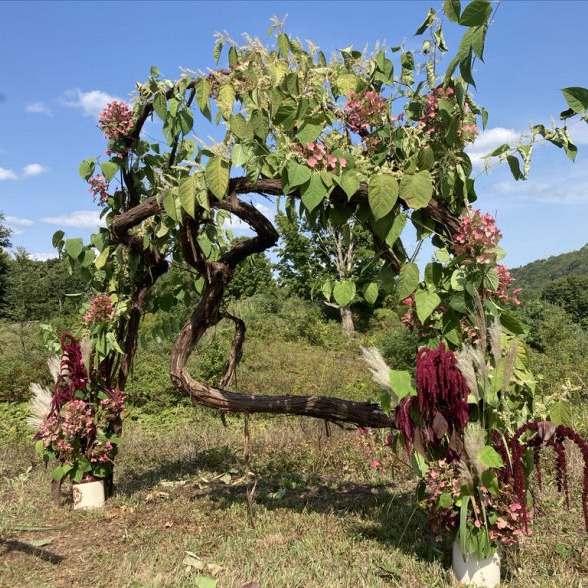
left=29, top=333, right=124, bottom=494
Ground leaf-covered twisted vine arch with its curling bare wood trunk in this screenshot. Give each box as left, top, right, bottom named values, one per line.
left=54, top=0, right=570, bottom=427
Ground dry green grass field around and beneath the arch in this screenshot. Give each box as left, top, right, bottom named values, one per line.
left=0, top=316, right=588, bottom=588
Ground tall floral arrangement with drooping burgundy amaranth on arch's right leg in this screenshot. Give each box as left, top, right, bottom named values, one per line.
left=363, top=210, right=588, bottom=560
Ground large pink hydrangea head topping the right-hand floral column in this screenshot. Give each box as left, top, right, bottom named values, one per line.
left=453, top=210, right=502, bottom=263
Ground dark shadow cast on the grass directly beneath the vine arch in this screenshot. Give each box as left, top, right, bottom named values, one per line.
left=116, top=445, right=449, bottom=562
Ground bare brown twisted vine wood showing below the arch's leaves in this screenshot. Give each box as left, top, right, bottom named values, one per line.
left=109, top=178, right=457, bottom=428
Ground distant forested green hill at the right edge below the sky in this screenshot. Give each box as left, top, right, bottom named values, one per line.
left=511, top=243, right=588, bottom=293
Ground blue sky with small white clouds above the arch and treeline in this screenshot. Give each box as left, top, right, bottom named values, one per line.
left=0, top=0, right=588, bottom=267
